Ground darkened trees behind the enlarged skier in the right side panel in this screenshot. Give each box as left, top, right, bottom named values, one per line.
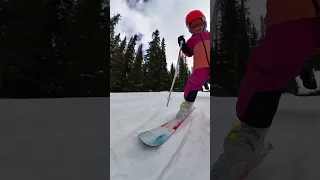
left=211, top=0, right=320, bottom=96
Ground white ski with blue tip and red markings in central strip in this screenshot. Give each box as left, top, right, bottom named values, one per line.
left=138, top=107, right=195, bottom=147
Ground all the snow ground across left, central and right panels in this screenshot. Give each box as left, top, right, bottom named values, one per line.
left=0, top=92, right=320, bottom=180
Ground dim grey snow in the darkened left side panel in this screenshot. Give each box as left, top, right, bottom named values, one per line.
left=0, top=98, right=109, bottom=180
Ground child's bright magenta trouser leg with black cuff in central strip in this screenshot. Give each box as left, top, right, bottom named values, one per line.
left=184, top=67, right=210, bottom=102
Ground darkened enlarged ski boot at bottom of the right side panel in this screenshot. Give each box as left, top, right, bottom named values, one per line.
left=211, top=123, right=268, bottom=180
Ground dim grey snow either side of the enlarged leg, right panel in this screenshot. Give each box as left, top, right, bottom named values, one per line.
left=210, top=94, right=320, bottom=180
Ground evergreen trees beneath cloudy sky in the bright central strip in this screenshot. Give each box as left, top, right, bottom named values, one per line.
left=110, top=14, right=190, bottom=92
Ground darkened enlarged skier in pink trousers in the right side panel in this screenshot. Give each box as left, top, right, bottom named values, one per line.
left=211, top=0, right=320, bottom=180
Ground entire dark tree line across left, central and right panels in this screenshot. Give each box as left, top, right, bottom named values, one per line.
left=0, top=0, right=320, bottom=98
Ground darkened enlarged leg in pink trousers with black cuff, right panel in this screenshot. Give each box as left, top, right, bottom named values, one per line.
left=237, top=18, right=320, bottom=128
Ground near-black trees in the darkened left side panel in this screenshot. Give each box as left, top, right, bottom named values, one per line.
left=0, top=0, right=110, bottom=98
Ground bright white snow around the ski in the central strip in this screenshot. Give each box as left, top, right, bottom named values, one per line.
left=110, top=92, right=210, bottom=180
